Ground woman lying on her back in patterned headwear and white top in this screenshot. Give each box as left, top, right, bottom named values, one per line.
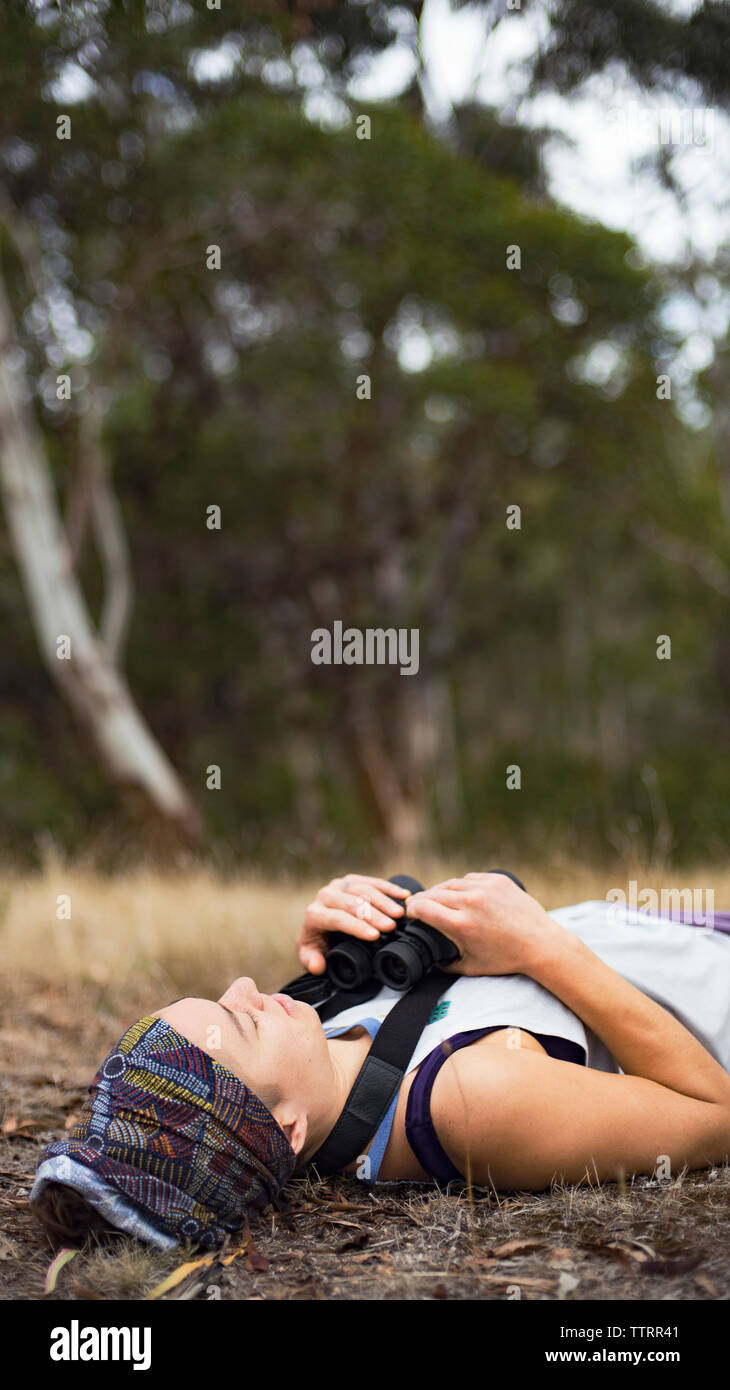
left=31, top=873, right=730, bottom=1248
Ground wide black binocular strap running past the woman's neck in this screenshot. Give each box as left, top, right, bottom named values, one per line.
left=304, top=970, right=453, bottom=1177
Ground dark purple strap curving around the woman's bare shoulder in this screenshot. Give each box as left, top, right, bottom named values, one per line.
left=406, top=1023, right=585, bottom=1183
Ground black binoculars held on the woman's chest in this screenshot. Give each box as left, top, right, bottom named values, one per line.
left=327, top=869, right=526, bottom=992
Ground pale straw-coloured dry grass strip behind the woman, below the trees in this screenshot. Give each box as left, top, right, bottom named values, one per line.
left=0, top=862, right=730, bottom=1002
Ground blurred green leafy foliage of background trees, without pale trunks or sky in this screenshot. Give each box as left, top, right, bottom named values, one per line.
left=0, top=6, right=730, bottom=865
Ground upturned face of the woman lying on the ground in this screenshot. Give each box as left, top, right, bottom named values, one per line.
left=159, top=976, right=331, bottom=1154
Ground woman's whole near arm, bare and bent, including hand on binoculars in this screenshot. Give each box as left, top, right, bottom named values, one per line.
left=412, top=874, right=730, bottom=1187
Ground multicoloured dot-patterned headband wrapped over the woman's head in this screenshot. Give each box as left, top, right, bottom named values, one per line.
left=31, top=1016, right=296, bottom=1250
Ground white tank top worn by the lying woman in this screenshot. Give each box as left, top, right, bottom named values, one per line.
left=321, top=901, right=730, bottom=1072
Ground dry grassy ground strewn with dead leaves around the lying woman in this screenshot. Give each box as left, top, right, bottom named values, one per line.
left=0, top=865, right=730, bottom=1300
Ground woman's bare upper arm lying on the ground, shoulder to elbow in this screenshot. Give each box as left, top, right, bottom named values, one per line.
left=431, top=1045, right=730, bottom=1191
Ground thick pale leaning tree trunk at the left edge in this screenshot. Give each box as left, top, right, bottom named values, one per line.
left=0, top=265, right=202, bottom=842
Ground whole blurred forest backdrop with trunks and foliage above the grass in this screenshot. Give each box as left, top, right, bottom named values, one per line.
left=0, top=0, right=730, bottom=872
